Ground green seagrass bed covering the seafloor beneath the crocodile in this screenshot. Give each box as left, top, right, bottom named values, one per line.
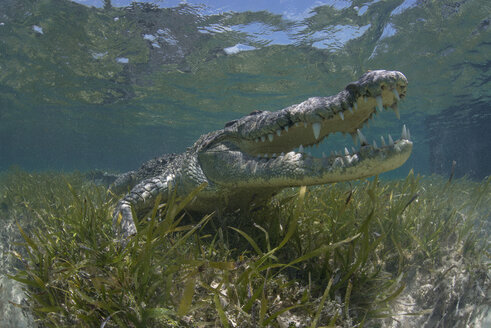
left=0, top=170, right=491, bottom=327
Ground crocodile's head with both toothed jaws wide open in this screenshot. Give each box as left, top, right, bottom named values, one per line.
left=198, top=70, right=412, bottom=188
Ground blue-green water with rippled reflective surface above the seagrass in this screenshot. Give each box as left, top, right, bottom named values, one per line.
left=0, top=0, right=491, bottom=178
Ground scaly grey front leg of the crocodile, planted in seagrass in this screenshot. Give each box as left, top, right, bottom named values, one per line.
left=113, top=176, right=174, bottom=238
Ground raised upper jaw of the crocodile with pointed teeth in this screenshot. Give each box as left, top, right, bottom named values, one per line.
left=233, top=71, right=407, bottom=156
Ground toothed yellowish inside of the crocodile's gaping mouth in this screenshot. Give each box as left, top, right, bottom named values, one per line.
left=240, top=73, right=411, bottom=163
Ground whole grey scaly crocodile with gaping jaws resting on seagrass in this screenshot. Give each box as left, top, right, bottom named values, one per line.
left=112, top=70, right=412, bottom=236
